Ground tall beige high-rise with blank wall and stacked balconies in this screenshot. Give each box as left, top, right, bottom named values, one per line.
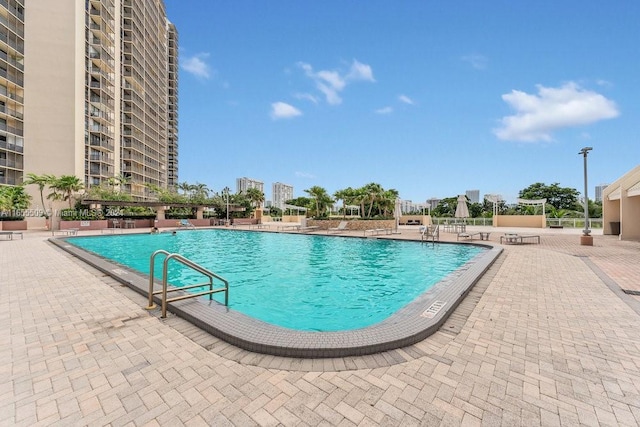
left=24, top=0, right=178, bottom=200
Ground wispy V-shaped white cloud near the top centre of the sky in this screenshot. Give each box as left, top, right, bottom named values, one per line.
left=298, top=59, right=375, bottom=105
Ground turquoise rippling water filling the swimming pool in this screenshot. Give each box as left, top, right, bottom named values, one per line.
left=68, top=230, right=485, bottom=331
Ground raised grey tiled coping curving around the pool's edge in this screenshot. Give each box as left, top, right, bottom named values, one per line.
left=49, top=232, right=503, bottom=358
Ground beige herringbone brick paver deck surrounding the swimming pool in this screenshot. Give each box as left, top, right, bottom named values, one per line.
left=0, top=226, right=640, bottom=426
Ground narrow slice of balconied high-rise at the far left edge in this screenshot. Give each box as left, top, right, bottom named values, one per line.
left=0, top=0, right=25, bottom=185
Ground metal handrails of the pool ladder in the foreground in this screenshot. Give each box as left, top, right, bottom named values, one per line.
left=146, top=249, right=229, bottom=319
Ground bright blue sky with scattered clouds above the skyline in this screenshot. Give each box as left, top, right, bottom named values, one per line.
left=165, top=0, right=640, bottom=202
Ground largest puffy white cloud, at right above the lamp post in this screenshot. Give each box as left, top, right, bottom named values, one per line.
left=493, top=82, right=620, bottom=142
